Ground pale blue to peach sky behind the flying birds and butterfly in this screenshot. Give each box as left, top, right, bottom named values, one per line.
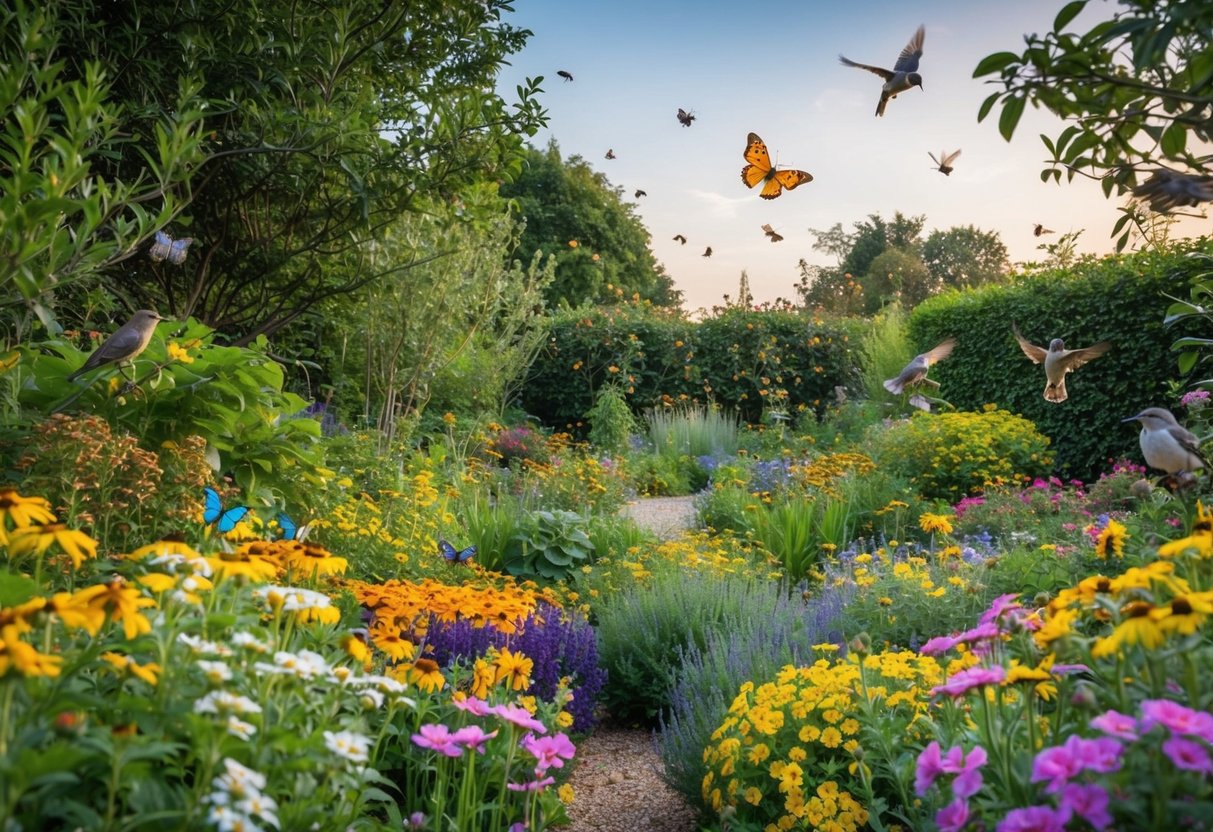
left=499, top=0, right=1208, bottom=310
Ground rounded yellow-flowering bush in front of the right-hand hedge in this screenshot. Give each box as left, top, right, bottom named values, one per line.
left=875, top=410, right=1053, bottom=501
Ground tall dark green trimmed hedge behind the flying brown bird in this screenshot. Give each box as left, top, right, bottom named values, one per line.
left=910, top=240, right=1213, bottom=481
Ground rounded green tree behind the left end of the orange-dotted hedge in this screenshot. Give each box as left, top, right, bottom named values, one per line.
left=501, top=139, right=682, bottom=307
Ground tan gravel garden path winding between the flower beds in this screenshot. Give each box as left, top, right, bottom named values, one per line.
left=566, top=497, right=697, bottom=832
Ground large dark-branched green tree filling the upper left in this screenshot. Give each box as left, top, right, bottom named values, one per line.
left=43, top=0, right=545, bottom=342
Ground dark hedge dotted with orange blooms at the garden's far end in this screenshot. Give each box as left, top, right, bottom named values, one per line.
left=522, top=303, right=862, bottom=433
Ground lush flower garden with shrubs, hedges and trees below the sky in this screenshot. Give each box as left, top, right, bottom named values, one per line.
left=0, top=0, right=1213, bottom=832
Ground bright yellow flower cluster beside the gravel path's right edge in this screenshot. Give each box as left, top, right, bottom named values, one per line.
left=702, top=650, right=945, bottom=832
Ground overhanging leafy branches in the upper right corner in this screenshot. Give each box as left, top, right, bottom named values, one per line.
left=973, top=0, right=1213, bottom=247
